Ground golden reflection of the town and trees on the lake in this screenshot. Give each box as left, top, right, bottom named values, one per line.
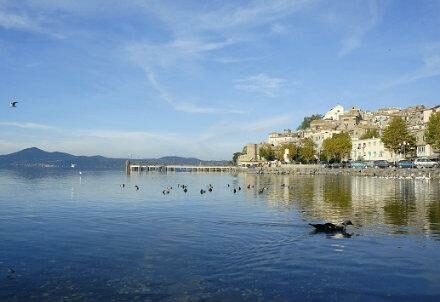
left=241, top=174, right=440, bottom=238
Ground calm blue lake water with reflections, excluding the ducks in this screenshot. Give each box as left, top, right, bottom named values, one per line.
left=0, top=170, right=440, bottom=302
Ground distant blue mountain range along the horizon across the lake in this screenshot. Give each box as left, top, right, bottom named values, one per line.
left=0, top=147, right=232, bottom=170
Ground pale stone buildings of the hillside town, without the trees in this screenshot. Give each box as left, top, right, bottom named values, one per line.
left=238, top=105, right=440, bottom=166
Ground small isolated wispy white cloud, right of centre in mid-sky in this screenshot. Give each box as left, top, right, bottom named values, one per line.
left=234, top=73, right=286, bottom=97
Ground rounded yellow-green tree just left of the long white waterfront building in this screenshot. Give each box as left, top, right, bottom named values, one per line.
left=322, top=132, right=352, bottom=161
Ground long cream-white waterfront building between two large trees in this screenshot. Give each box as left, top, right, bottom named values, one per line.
left=351, top=138, right=394, bottom=161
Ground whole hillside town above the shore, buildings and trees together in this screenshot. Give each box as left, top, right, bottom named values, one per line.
left=237, top=105, right=440, bottom=167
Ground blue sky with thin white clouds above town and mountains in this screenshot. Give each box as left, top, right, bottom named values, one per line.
left=0, top=0, right=440, bottom=159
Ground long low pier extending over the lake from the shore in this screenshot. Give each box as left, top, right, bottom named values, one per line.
left=125, top=161, right=238, bottom=174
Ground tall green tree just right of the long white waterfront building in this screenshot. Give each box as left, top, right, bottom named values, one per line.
left=382, top=116, right=416, bottom=153
